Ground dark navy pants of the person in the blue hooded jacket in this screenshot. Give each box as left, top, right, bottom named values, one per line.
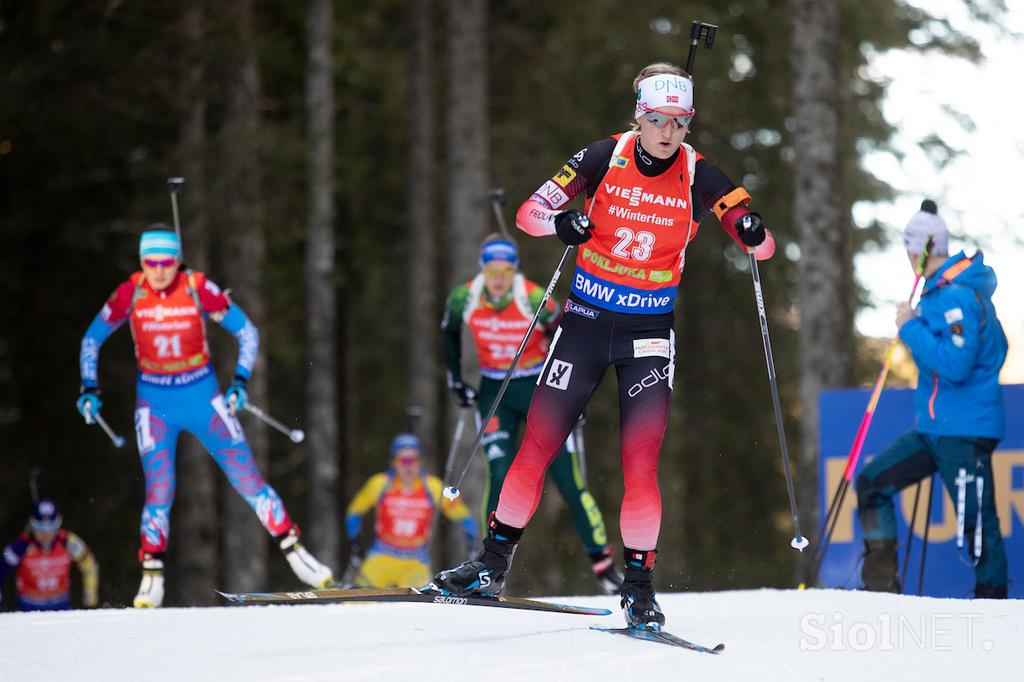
left=857, top=431, right=1007, bottom=588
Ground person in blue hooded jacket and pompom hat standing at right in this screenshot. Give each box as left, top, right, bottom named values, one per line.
left=856, top=200, right=1007, bottom=599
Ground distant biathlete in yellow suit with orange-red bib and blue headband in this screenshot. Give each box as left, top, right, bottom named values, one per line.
left=345, top=433, right=480, bottom=587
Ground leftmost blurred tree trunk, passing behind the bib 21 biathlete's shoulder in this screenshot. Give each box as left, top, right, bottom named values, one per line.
left=168, top=0, right=217, bottom=606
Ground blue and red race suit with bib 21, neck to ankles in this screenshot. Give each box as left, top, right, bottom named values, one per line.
left=80, top=270, right=292, bottom=553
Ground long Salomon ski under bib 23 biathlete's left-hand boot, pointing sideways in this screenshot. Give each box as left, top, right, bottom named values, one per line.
left=217, top=586, right=611, bottom=615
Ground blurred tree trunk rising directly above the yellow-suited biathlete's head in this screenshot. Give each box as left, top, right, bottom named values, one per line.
left=408, top=0, right=446, bottom=471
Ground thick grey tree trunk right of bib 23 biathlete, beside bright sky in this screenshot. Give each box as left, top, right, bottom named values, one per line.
left=790, top=0, right=851, bottom=569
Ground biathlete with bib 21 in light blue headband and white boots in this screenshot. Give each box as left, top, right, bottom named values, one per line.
left=77, top=229, right=334, bottom=608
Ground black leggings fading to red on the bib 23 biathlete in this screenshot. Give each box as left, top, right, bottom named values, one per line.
left=497, top=298, right=675, bottom=550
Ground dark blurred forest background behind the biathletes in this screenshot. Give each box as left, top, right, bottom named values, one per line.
left=0, top=0, right=1005, bottom=605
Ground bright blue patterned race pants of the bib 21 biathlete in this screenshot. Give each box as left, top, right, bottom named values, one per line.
left=135, top=372, right=292, bottom=553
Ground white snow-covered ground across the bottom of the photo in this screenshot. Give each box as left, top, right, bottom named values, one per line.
left=0, top=590, right=1024, bottom=682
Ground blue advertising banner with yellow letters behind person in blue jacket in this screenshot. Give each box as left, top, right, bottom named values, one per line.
left=818, top=385, right=1024, bottom=598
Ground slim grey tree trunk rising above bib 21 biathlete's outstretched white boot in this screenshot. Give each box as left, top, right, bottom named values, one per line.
left=306, top=0, right=341, bottom=566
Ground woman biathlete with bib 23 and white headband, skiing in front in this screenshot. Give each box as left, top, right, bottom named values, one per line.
left=434, top=63, right=774, bottom=629
